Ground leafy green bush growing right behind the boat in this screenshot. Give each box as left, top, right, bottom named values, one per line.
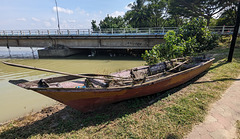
left=142, top=18, right=218, bottom=65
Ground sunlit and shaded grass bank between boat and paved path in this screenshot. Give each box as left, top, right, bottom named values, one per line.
left=0, top=36, right=240, bottom=138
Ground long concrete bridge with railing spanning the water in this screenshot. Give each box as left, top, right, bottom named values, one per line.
left=0, top=26, right=236, bottom=57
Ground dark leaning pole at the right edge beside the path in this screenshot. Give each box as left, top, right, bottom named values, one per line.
left=228, top=0, right=240, bottom=62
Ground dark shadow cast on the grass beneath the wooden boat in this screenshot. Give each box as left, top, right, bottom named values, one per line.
left=0, top=72, right=210, bottom=138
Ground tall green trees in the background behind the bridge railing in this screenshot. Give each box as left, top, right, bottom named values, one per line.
left=92, top=0, right=237, bottom=29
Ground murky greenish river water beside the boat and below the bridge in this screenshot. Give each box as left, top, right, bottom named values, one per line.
left=0, top=57, right=145, bottom=123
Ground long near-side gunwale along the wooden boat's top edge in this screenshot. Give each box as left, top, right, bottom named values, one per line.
left=26, top=58, right=215, bottom=92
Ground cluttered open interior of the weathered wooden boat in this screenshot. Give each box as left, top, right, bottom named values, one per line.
left=9, top=57, right=209, bottom=89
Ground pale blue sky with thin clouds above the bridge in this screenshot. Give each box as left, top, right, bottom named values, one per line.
left=0, top=0, right=134, bottom=30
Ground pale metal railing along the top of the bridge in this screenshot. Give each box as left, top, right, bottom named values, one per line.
left=0, top=26, right=236, bottom=36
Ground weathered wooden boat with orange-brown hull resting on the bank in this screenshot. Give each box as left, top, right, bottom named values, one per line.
left=5, top=57, right=214, bottom=112
